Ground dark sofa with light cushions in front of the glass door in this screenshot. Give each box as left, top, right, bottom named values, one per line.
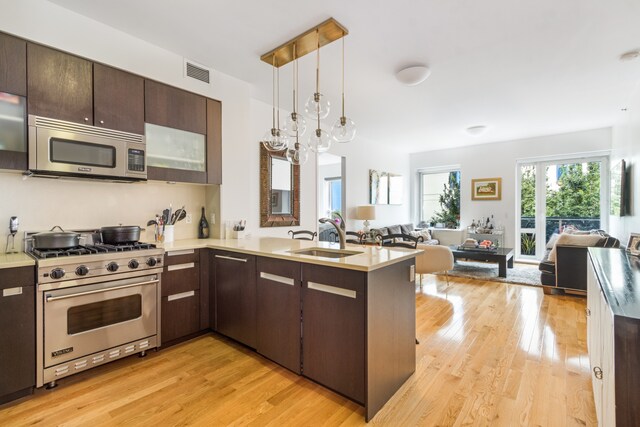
left=538, top=230, right=620, bottom=294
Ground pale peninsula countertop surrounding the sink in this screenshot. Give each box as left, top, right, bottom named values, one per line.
left=158, top=237, right=422, bottom=271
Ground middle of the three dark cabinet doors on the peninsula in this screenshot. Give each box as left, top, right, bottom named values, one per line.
left=256, top=258, right=301, bottom=374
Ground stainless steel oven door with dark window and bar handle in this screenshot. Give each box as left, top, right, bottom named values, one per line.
left=43, top=274, right=159, bottom=368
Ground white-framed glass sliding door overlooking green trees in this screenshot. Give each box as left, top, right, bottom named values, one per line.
left=516, top=157, right=608, bottom=260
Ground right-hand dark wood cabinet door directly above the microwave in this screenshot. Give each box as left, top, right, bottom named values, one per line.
left=93, top=64, right=144, bottom=134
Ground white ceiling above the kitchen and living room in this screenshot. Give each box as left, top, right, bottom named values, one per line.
left=48, top=0, right=640, bottom=152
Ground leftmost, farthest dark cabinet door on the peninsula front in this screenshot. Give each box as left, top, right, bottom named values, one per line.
left=214, top=252, right=256, bottom=348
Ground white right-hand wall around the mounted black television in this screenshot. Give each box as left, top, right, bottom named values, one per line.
left=609, top=85, right=640, bottom=245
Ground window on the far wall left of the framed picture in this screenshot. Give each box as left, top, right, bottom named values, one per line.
left=419, top=169, right=460, bottom=228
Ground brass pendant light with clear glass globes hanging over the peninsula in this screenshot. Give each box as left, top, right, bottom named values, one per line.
left=260, top=18, right=355, bottom=164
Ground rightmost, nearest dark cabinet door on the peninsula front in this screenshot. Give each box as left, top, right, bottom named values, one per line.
left=302, top=264, right=366, bottom=403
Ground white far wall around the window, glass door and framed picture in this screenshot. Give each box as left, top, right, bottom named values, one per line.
left=411, top=128, right=611, bottom=247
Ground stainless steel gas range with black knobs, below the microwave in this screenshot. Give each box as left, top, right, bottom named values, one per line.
left=25, top=232, right=164, bottom=387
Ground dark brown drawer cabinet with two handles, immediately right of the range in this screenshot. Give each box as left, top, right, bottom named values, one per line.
left=161, top=249, right=202, bottom=345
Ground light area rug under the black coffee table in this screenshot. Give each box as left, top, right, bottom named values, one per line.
left=439, top=260, right=542, bottom=286
